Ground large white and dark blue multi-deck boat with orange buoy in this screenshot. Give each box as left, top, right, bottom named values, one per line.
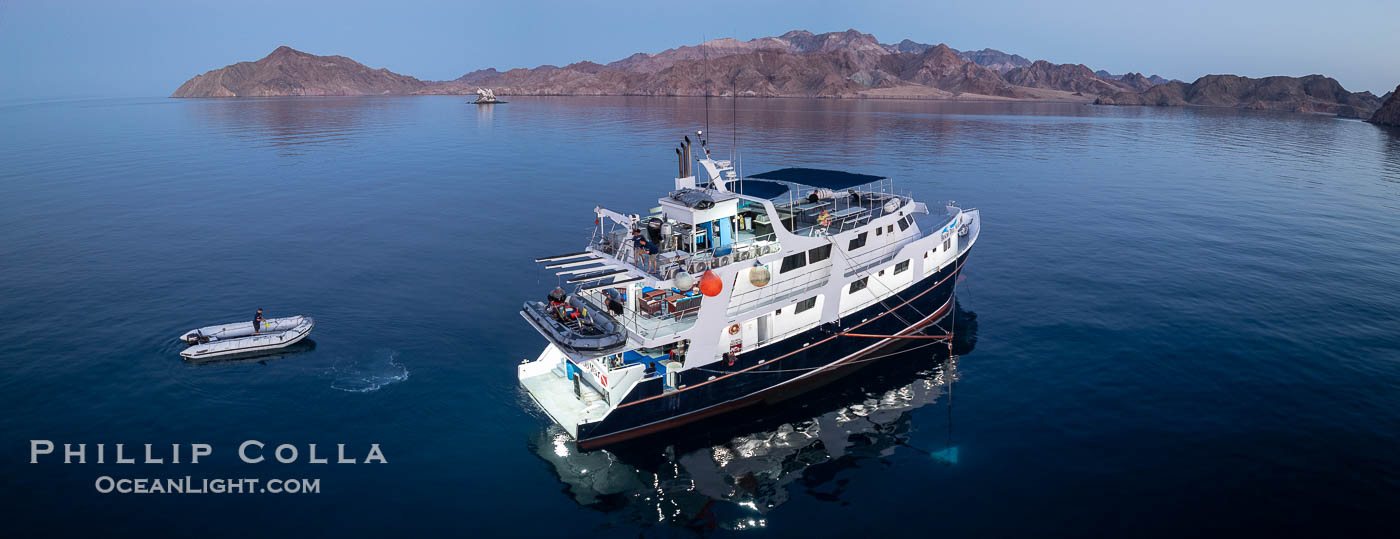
left=518, top=137, right=981, bottom=449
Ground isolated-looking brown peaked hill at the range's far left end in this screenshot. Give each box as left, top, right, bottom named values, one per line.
left=171, top=46, right=428, bottom=98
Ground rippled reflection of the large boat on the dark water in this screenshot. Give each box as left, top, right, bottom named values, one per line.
left=529, top=305, right=977, bottom=529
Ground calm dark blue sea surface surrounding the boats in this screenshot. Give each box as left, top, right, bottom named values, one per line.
left=0, top=97, right=1400, bottom=536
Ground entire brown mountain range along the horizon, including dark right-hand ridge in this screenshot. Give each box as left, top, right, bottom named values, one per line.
left=172, top=29, right=1382, bottom=118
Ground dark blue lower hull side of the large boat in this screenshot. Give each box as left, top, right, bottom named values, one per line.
left=578, top=252, right=967, bottom=449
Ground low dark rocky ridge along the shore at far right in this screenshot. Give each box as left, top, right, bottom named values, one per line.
left=1095, top=74, right=1380, bottom=118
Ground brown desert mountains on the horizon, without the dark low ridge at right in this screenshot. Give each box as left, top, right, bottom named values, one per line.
left=174, top=29, right=1127, bottom=101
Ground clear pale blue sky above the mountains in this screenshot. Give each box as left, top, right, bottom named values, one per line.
left=0, top=0, right=1400, bottom=98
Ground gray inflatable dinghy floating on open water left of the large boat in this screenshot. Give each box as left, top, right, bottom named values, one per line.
left=179, top=315, right=316, bottom=360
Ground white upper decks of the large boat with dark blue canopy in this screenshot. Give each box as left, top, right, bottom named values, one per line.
left=538, top=136, right=952, bottom=346
